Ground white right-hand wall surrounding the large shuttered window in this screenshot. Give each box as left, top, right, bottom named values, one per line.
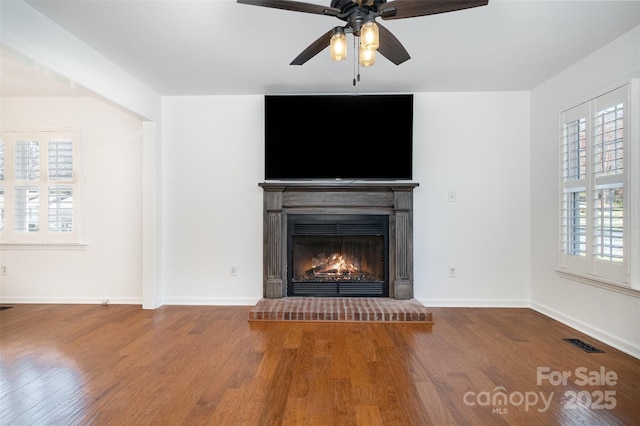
left=531, top=23, right=640, bottom=357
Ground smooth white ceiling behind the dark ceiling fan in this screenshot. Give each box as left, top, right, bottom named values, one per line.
left=0, top=0, right=640, bottom=96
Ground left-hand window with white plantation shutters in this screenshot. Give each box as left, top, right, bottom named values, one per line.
left=0, top=130, right=79, bottom=244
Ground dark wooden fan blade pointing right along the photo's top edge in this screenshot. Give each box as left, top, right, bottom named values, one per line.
left=378, top=0, right=489, bottom=20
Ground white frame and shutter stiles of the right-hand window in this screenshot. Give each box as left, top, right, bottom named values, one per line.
left=558, top=79, right=640, bottom=296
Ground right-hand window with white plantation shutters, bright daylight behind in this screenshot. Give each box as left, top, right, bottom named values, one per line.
left=560, top=86, right=638, bottom=286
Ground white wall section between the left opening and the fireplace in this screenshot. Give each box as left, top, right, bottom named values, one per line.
left=162, top=96, right=264, bottom=304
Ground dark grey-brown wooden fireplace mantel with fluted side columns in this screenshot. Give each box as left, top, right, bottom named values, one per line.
left=258, top=181, right=419, bottom=300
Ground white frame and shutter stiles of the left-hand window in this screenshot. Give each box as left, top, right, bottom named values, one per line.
left=0, top=127, right=85, bottom=246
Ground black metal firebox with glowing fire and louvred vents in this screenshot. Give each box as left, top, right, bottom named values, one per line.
left=287, top=214, right=389, bottom=297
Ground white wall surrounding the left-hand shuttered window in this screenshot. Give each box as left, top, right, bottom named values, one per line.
left=0, top=98, right=142, bottom=304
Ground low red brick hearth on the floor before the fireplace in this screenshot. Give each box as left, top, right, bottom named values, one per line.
left=249, top=297, right=433, bottom=327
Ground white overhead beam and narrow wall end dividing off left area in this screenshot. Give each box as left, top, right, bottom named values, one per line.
left=0, top=0, right=162, bottom=308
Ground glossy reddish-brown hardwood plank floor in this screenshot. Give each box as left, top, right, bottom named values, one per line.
left=0, top=305, right=640, bottom=426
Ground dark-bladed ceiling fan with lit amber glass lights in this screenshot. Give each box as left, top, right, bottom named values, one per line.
left=237, top=0, right=489, bottom=66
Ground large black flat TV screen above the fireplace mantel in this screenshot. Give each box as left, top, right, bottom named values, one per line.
left=264, top=94, right=413, bottom=180
